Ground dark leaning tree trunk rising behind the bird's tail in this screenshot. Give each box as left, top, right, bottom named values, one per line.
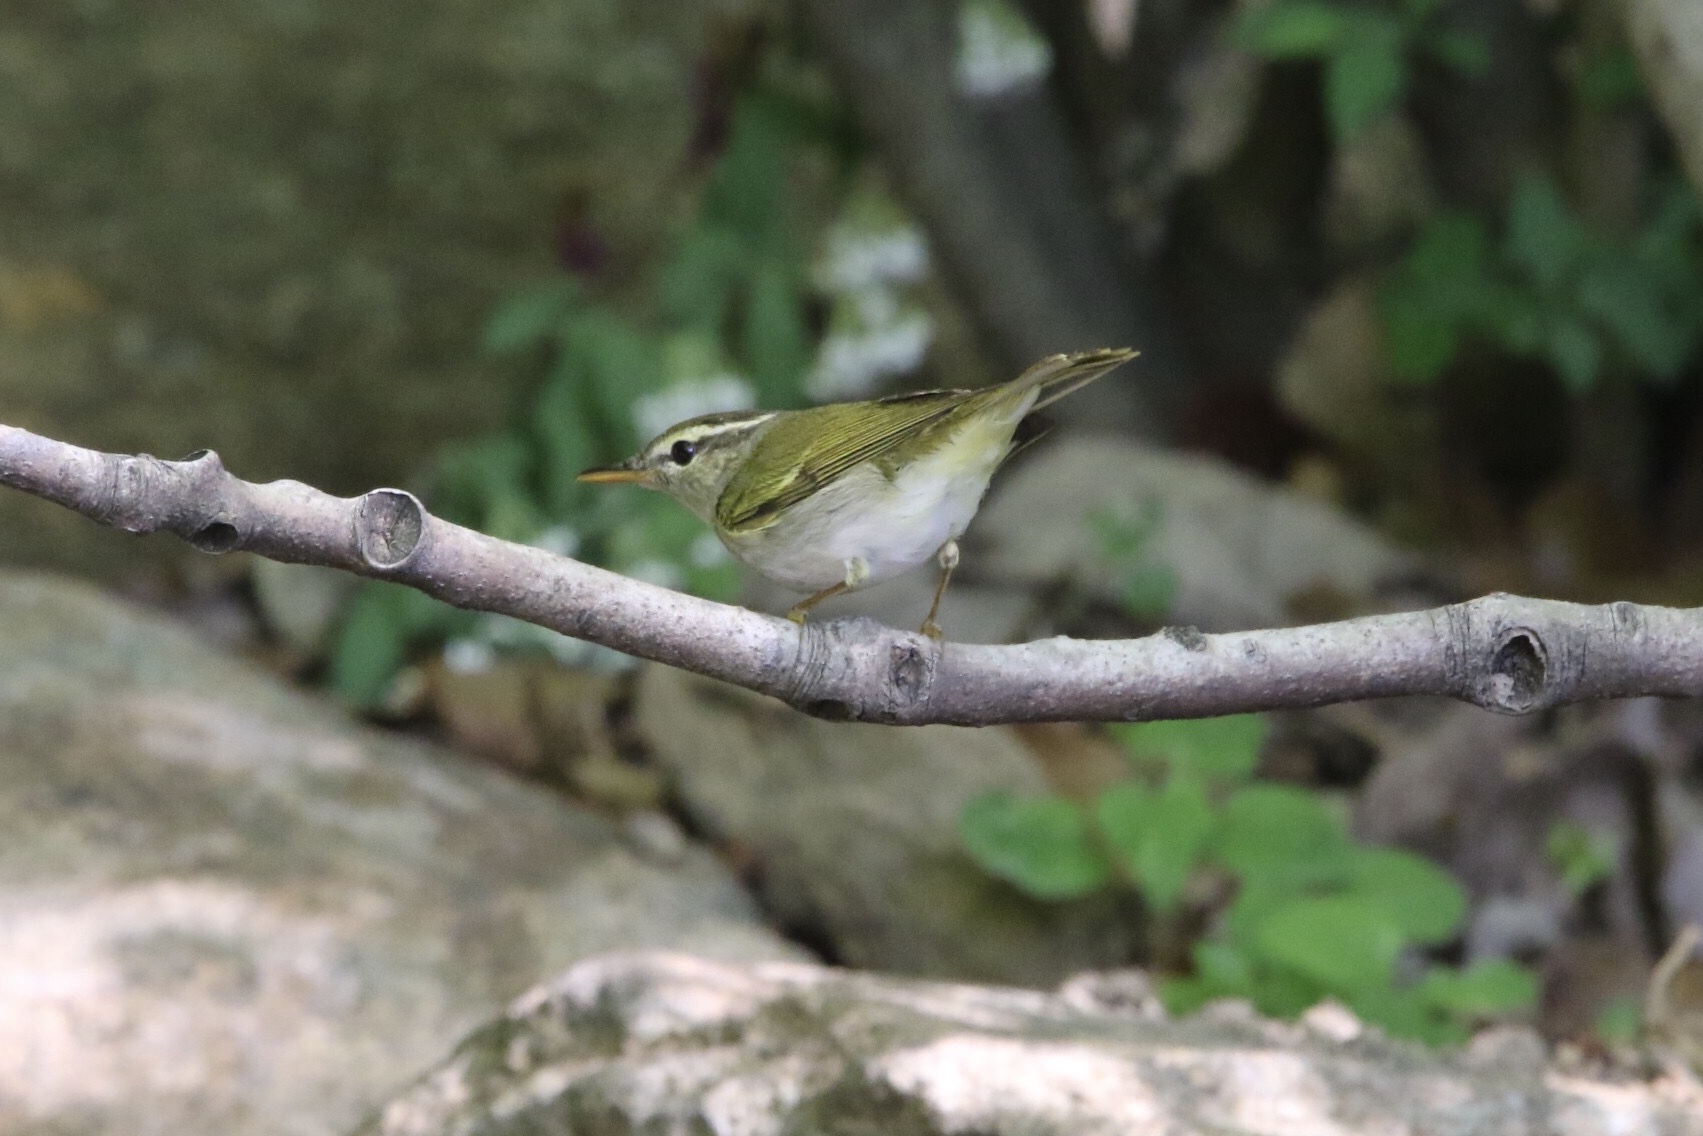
left=800, top=0, right=1190, bottom=438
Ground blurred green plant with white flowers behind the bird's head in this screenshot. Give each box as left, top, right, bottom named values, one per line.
left=330, top=83, right=855, bottom=707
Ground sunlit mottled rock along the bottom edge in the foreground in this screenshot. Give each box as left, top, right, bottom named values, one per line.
left=359, top=954, right=1703, bottom=1136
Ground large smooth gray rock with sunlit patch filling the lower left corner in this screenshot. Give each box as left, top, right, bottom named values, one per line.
left=0, top=574, right=799, bottom=1136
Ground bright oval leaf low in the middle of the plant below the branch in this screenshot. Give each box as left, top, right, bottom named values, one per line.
left=1257, top=896, right=1403, bottom=991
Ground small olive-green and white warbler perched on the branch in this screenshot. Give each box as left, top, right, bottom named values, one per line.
left=579, top=349, right=1136, bottom=639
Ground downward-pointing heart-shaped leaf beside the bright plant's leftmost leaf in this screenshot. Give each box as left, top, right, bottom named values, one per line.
left=1095, top=775, right=1213, bottom=913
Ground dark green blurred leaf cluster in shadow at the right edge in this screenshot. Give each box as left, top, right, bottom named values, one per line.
left=1381, top=175, right=1703, bottom=392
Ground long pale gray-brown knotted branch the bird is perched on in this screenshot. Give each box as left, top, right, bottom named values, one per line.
left=0, top=426, right=1703, bottom=726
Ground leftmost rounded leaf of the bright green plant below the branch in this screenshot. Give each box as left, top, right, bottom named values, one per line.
left=959, top=792, right=1110, bottom=899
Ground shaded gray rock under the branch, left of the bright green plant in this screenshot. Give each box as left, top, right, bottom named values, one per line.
left=634, top=668, right=1136, bottom=986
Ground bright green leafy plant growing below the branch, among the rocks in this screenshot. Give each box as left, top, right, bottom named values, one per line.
left=960, top=715, right=1538, bottom=1044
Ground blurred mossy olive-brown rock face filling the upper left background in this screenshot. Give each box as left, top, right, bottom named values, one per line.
left=0, top=0, right=768, bottom=574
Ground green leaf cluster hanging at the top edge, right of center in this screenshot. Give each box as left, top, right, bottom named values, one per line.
left=1236, top=0, right=1490, bottom=143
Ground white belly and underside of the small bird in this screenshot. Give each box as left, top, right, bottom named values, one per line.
left=725, top=405, right=1027, bottom=593
